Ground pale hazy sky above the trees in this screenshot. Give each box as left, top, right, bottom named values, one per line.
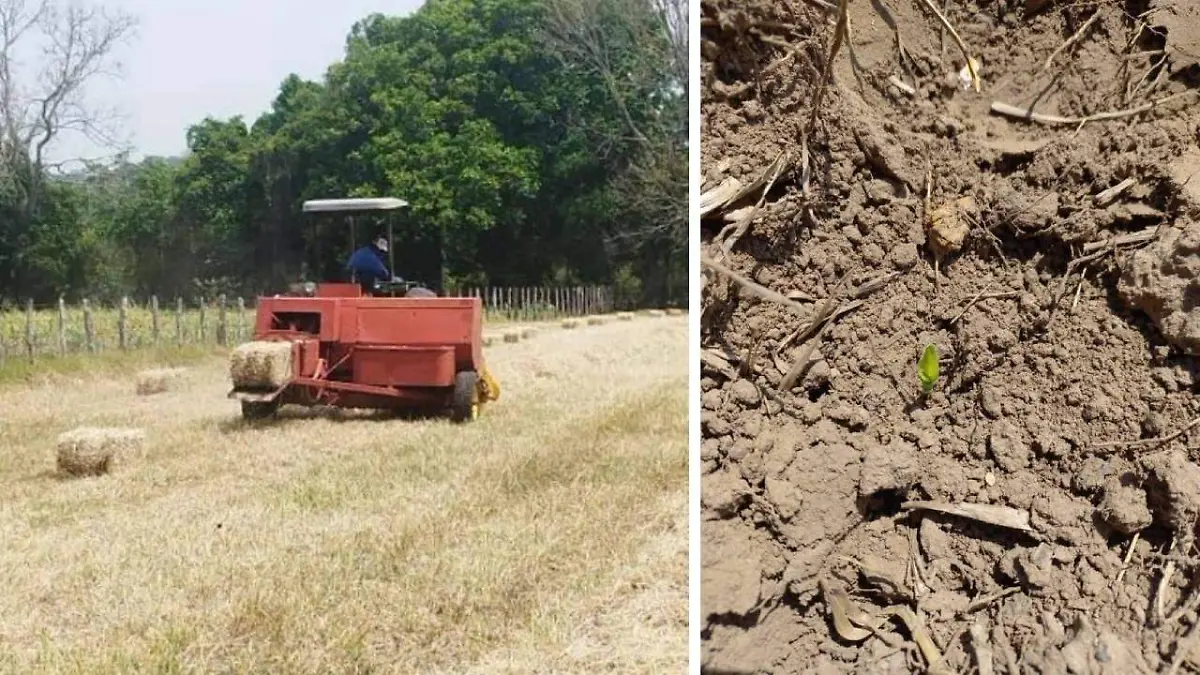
left=53, top=0, right=422, bottom=160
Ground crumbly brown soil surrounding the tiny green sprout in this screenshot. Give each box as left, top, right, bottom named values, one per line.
left=701, top=0, right=1200, bottom=674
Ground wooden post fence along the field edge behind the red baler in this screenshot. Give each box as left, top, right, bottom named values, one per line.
left=0, top=286, right=614, bottom=368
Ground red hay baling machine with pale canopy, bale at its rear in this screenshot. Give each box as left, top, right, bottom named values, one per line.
left=229, top=198, right=500, bottom=422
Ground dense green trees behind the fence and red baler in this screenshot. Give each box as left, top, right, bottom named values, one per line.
left=0, top=0, right=688, bottom=303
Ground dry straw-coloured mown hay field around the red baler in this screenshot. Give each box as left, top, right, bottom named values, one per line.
left=0, top=316, right=688, bottom=674
